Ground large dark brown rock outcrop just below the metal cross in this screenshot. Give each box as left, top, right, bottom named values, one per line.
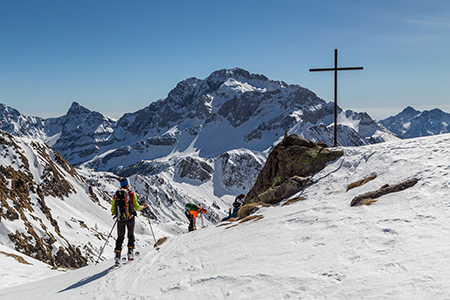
left=245, top=134, right=343, bottom=203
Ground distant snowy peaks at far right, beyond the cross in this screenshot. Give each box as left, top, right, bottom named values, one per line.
left=380, top=106, right=450, bottom=139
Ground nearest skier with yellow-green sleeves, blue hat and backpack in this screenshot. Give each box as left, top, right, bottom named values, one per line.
left=111, top=178, right=147, bottom=264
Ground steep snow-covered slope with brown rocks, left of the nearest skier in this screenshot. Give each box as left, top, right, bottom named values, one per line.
left=0, top=131, right=115, bottom=268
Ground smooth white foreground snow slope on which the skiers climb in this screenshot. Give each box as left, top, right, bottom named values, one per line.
left=0, top=134, right=450, bottom=300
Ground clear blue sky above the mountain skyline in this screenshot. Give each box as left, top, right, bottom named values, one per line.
left=0, top=0, right=450, bottom=120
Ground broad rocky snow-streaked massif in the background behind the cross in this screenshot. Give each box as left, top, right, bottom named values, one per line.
left=0, top=68, right=394, bottom=172
